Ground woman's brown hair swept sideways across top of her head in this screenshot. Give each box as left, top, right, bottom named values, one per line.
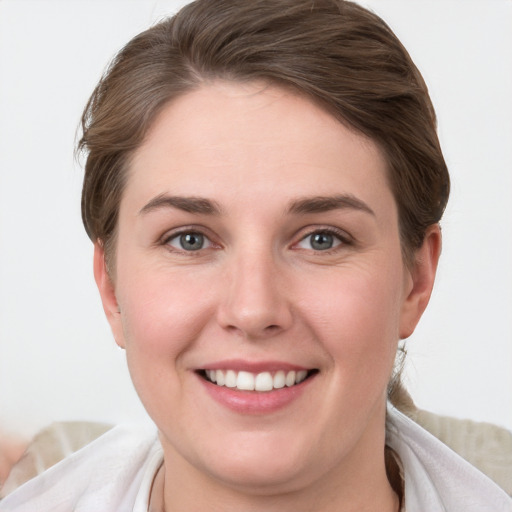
left=78, top=0, right=450, bottom=261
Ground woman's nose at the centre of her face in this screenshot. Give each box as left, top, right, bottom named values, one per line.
left=218, top=253, right=293, bottom=340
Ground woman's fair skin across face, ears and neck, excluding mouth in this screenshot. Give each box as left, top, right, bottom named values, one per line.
left=95, top=82, right=441, bottom=512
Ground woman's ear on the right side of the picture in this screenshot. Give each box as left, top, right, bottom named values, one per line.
left=400, top=224, right=442, bottom=339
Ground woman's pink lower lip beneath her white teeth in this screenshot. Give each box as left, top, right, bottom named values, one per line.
left=197, top=375, right=315, bottom=414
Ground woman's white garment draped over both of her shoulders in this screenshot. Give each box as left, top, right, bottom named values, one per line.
left=0, top=406, right=512, bottom=512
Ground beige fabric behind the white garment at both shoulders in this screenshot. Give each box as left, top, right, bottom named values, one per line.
left=0, top=402, right=512, bottom=498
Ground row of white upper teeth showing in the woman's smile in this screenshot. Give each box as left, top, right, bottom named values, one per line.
left=198, top=370, right=318, bottom=392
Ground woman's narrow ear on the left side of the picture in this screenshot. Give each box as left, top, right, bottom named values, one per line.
left=94, top=242, right=125, bottom=348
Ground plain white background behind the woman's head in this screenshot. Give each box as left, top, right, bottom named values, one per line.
left=0, top=0, right=512, bottom=435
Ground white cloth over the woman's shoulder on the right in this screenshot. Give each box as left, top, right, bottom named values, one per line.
left=387, top=406, right=512, bottom=512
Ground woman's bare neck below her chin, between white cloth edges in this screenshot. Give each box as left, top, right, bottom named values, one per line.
left=156, top=430, right=399, bottom=512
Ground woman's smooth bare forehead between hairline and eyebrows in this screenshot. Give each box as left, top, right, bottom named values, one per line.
left=127, top=82, right=389, bottom=216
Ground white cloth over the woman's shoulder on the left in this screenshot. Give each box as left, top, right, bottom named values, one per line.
left=0, top=426, right=162, bottom=512
